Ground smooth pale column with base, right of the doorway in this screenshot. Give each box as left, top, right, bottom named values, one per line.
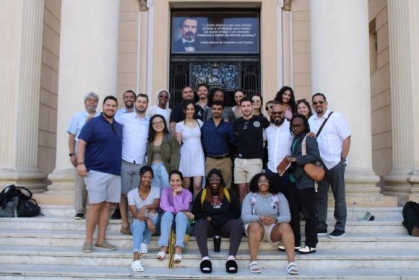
left=310, top=0, right=395, bottom=206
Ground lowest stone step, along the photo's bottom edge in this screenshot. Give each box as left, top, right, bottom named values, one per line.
left=0, top=264, right=419, bottom=280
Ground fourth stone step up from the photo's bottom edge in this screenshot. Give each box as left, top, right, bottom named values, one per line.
left=0, top=216, right=407, bottom=233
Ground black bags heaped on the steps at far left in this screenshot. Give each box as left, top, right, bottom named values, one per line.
left=0, top=185, right=41, bottom=217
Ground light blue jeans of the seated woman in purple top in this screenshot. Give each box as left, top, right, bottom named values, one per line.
left=159, top=212, right=190, bottom=248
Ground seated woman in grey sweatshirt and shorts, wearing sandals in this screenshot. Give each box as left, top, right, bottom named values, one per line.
left=241, top=173, right=298, bottom=274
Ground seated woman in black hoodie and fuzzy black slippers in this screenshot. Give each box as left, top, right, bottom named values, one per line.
left=192, top=169, right=243, bottom=273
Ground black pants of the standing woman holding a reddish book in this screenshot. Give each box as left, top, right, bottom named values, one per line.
left=288, top=182, right=318, bottom=248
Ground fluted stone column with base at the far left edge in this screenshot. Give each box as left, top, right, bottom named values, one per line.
left=0, top=0, right=45, bottom=192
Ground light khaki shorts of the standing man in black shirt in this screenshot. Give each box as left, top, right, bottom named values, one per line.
left=234, top=158, right=262, bottom=184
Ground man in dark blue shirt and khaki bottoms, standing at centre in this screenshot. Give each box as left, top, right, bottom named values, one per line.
left=201, top=101, right=237, bottom=188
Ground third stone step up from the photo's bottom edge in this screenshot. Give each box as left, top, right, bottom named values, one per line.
left=0, top=230, right=418, bottom=252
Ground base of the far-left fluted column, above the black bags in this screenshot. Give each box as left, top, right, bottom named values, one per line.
left=0, top=167, right=46, bottom=193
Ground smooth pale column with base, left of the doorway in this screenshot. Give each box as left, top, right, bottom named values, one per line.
left=46, top=0, right=120, bottom=203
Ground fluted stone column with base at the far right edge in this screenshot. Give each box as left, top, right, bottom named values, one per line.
left=384, top=0, right=419, bottom=202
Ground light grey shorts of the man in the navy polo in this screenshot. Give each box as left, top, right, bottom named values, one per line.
left=84, top=170, right=121, bottom=204
